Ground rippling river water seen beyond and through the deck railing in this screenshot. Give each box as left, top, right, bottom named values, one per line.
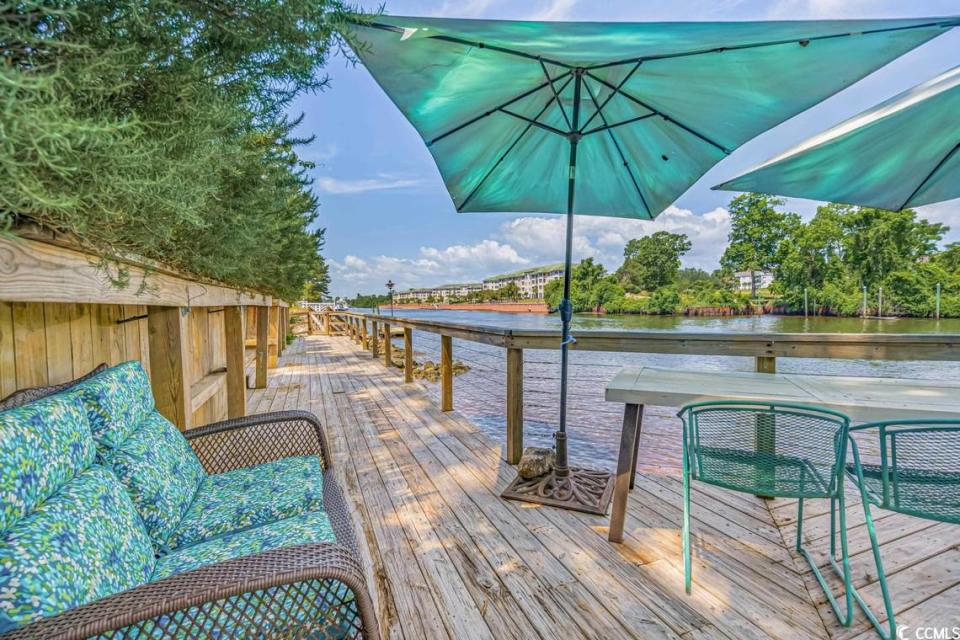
left=362, top=307, right=960, bottom=469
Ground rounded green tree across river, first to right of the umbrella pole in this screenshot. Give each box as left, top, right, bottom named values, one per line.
left=617, top=231, right=692, bottom=291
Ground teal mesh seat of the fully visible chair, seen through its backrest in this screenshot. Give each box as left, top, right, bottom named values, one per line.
left=691, top=447, right=832, bottom=498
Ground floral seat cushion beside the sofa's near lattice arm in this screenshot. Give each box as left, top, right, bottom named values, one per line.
left=151, top=511, right=336, bottom=581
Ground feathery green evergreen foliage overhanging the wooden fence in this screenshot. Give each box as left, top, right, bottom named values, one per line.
left=0, top=0, right=360, bottom=300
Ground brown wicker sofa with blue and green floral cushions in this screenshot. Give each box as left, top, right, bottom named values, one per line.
left=0, top=362, right=378, bottom=638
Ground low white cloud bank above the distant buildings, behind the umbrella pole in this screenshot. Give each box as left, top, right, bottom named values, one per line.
left=329, top=207, right=730, bottom=295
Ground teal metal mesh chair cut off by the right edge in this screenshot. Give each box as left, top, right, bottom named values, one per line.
left=848, top=419, right=960, bottom=640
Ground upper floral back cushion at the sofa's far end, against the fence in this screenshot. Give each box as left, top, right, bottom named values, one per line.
left=74, top=360, right=155, bottom=451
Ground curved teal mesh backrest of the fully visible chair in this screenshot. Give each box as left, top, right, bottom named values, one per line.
left=679, top=400, right=850, bottom=497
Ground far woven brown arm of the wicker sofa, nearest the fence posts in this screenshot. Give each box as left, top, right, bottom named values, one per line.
left=183, top=411, right=333, bottom=473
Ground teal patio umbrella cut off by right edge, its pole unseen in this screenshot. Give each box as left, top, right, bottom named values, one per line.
left=714, top=66, right=960, bottom=211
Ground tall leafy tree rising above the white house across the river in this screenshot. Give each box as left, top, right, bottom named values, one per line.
left=720, top=193, right=800, bottom=296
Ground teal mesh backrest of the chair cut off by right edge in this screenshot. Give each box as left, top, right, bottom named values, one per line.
left=851, top=418, right=960, bottom=523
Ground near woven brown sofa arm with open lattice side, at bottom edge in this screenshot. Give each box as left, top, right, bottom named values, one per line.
left=2, top=542, right=379, bottom=640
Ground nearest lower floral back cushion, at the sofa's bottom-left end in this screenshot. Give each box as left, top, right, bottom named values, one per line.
left=0, top=465, right=156, bottom=632
